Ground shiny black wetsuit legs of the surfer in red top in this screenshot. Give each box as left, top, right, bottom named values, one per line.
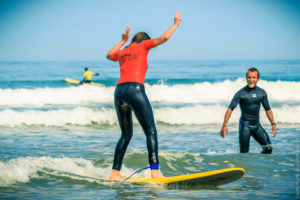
left=113, top=82, right=158, bottom=170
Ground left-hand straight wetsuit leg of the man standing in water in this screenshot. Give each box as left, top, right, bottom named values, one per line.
left=239, top=122, right=251, bottom=153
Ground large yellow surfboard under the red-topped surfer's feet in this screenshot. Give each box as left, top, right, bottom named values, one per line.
left=127, top=168, right=245, bottom=187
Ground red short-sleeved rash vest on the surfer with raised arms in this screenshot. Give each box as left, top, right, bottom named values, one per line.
left=111, top=39, right=155, bottom=85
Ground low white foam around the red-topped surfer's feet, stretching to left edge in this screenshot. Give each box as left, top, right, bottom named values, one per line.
left=0, top=156, right=155, bottom=187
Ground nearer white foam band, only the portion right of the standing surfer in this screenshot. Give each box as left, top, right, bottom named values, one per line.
left=154, top=105, right=300, bottom=125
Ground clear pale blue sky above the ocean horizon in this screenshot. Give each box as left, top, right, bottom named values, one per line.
left=0, top=0, right=300, bottom=61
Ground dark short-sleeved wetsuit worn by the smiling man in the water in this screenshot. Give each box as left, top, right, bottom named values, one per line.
left=229, top=86, right=272, bottom=153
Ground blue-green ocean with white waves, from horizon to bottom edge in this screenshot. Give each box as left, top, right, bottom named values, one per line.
left=0, top=60, right=300, bottom=199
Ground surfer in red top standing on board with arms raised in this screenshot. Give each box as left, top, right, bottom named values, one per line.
left=107, top=13, right=181, bottom=180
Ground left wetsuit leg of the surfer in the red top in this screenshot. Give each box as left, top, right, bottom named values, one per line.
left=113, top=99, right=133, bottom=170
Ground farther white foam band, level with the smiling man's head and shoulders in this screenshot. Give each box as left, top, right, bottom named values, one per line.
left=0, top=79, right=300, bottom=107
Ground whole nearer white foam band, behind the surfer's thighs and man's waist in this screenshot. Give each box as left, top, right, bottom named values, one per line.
left=0, top=105, right=300, bottom=127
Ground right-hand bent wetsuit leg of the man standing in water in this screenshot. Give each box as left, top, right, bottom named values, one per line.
left=252, top=123, right=273, bottom=154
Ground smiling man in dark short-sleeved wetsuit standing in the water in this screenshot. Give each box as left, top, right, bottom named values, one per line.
left=220, top=68, right=277, bottom=154
